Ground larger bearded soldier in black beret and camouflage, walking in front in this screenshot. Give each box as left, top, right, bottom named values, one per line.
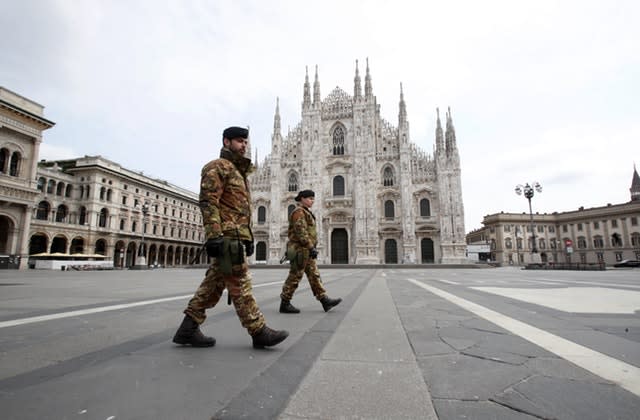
left=173, top=127, right=289, bottom=349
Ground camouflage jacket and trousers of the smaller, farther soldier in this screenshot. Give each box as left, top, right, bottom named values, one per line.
left=280, top=206, right=327, bottom=302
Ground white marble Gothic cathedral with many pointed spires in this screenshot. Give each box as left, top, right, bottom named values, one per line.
left=250, top=61, right=467, bottom=264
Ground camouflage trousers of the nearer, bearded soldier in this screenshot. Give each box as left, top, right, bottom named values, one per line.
left=184, top=259, right=266, bottom=335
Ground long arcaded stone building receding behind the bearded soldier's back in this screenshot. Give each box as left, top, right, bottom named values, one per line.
left=28, top=156, right=206, bottom=268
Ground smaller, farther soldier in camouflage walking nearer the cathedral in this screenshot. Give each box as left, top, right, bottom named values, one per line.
left=280, top=190, right=342, bottom=314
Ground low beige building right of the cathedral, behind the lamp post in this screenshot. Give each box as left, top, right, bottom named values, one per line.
left=467, top=168, right=640, bottom=265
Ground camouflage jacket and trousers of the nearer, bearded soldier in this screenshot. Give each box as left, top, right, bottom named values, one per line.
left=184, top=147, right=265, bottom=335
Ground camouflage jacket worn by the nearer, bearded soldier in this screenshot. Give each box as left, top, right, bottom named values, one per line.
left=200, top=147, right=254, bottom=241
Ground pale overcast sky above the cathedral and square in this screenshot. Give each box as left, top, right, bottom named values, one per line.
left=0, top=0, right=640, bottom=231
